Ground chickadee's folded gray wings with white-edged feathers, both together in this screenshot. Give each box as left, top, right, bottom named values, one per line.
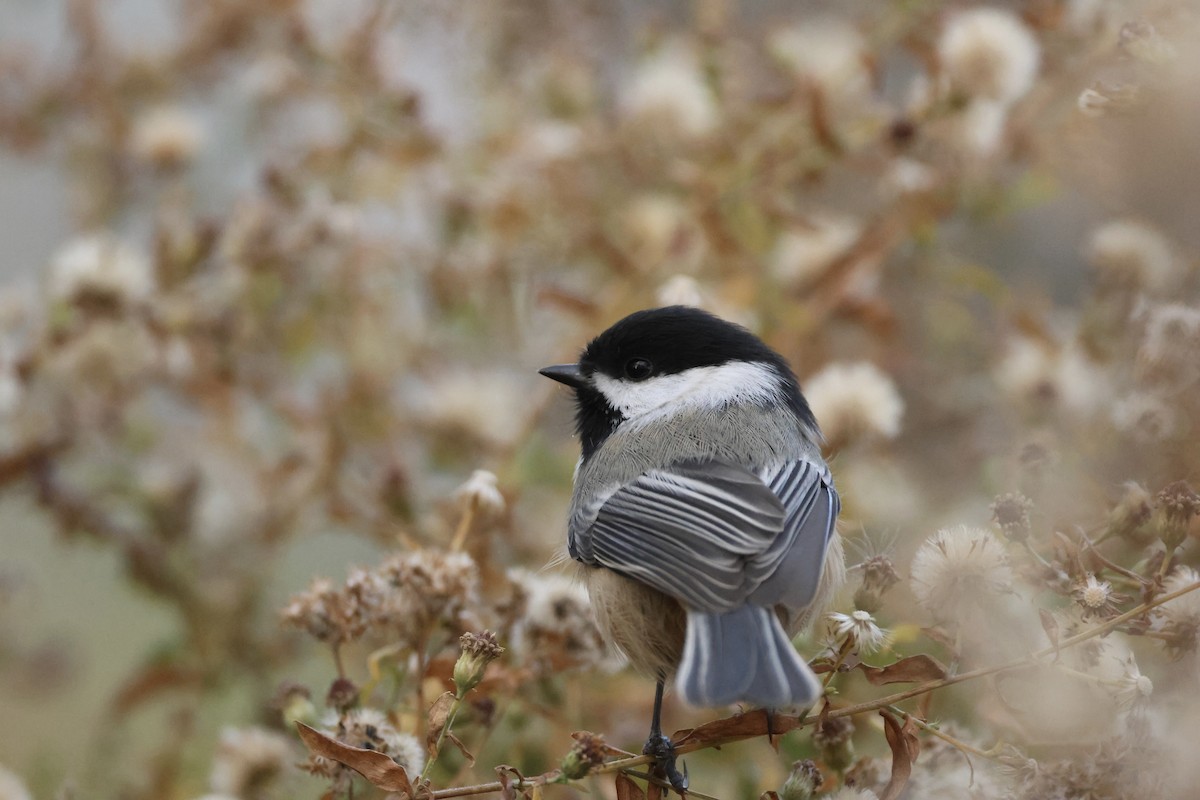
left=569, top=461, right=836, bottom=613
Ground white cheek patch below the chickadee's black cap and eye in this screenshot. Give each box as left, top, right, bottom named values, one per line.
left=592, top=361, right=781, bottom=420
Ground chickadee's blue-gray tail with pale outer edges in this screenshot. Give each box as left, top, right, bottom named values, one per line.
left=676, top=606, right=821, bottom=709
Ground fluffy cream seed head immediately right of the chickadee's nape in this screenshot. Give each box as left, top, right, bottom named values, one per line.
left=804, top=361, right=904, bottom=443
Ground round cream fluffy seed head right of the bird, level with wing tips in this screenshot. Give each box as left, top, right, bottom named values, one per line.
left=912, top=525, right=1013, bottom=619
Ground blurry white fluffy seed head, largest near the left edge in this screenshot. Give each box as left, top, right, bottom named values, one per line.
left=48, top=233, right=155, bottom=305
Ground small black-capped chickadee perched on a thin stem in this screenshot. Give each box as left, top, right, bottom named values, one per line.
left=540, top=306, right=844, bottom=788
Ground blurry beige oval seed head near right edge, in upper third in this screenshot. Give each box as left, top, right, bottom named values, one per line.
left=1085, top=219, right=1178, bottom=291
